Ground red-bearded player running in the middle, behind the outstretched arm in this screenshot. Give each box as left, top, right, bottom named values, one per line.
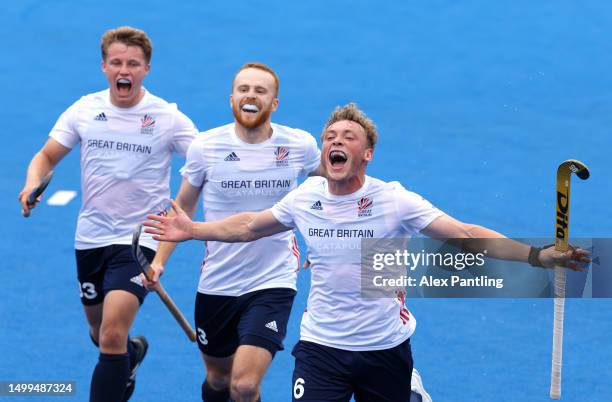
left=145, top=63, right=320, bottom=402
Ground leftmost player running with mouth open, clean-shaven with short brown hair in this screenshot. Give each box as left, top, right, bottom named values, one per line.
left=19, top=27, right=197, bottom=402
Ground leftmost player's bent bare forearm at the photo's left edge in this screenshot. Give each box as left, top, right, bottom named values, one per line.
left=18, top=138, right=70, bottom=216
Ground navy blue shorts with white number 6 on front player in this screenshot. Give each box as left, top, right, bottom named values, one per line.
left=291, top=339, right=413, bottom=402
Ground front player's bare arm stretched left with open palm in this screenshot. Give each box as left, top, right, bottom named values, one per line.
left=144, top=201, right=291, bottom=243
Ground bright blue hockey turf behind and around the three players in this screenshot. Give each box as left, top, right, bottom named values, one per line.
left=0, top=0, right=612, bottom=402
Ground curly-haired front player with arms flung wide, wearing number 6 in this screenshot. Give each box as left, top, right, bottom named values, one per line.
left=145, top=104, right=587, bottom=402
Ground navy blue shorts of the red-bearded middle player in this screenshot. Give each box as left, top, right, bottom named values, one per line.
left=195, top=288, right=296, bottom=357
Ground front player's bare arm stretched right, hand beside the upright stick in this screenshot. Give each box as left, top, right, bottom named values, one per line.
left=421, top=215, right=590, bottom=270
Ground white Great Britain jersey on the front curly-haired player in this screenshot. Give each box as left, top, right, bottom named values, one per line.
left=272, top=176, right=443, bottom=351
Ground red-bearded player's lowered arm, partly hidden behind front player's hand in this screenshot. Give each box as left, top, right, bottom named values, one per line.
left=142, top=178, right=200, bottom=289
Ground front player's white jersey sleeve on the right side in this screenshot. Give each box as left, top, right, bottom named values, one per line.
left=394, top=183, right=444, bottom=235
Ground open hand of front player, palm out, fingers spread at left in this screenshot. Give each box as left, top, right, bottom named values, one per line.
left=143, top=200, right=193, bottom=242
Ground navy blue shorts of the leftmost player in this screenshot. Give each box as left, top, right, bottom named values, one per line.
left=76, top=244, right=155, bottom=306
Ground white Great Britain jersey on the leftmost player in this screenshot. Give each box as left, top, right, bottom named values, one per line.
left=49, top=89, right=197, bottom=250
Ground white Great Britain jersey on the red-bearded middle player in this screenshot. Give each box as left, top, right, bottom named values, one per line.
left=181, top=123, right=321, bottom=296
